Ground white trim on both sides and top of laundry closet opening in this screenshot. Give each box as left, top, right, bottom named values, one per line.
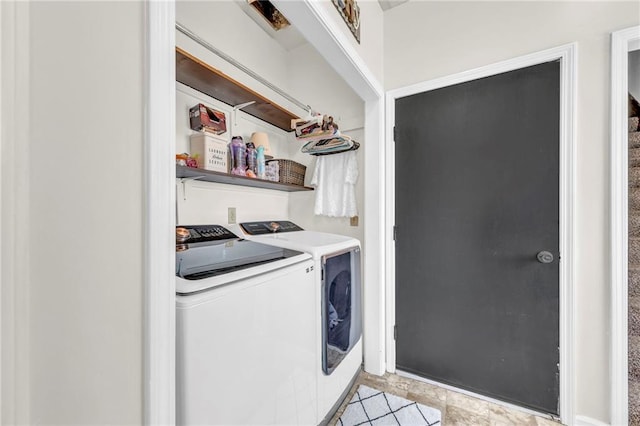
left=143, top=0, right=384, bottom=424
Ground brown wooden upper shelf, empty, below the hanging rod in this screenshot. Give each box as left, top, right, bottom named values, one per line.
left=176, top=47, right=299, bottom=132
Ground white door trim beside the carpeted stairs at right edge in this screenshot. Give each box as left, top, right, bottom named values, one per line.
left=610, top=26, right=640, bottom=425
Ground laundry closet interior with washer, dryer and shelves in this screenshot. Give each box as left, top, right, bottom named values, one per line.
left=176, top=1, right=366, bottom=425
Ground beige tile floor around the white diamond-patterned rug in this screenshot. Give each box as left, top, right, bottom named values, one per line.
left=329, top=371, right=560, bottom=426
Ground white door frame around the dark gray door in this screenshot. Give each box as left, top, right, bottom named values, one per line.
left=385, top=43, right=577, bottom=424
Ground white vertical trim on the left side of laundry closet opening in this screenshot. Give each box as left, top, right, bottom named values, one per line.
left=143, top=1, right=176, bottom=425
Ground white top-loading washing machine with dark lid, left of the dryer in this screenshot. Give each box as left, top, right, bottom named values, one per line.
left=176, top=225, right=317, bottom=425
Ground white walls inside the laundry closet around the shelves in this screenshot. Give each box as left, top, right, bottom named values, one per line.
left=176, top=1, right=366, bottom=241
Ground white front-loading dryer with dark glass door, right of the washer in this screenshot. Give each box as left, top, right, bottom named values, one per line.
left=233, top=220, right=362, bottom=424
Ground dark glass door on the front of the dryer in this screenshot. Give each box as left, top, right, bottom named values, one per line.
left=322, top=247, right=362, bottom=375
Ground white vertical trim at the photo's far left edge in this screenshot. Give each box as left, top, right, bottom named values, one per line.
left=0, top=2, right=31, bottom=424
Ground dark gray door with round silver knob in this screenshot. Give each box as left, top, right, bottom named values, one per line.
left=395, top=62, right=560, bottom=414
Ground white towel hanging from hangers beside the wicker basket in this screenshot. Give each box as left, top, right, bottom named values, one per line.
left=311, top=151, right=358, bottom=217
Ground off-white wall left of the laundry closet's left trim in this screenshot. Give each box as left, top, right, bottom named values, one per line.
left=3, top=2, right=144, bottom=425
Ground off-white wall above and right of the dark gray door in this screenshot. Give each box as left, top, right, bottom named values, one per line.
left=384, top=2, right=640, bottom=422
